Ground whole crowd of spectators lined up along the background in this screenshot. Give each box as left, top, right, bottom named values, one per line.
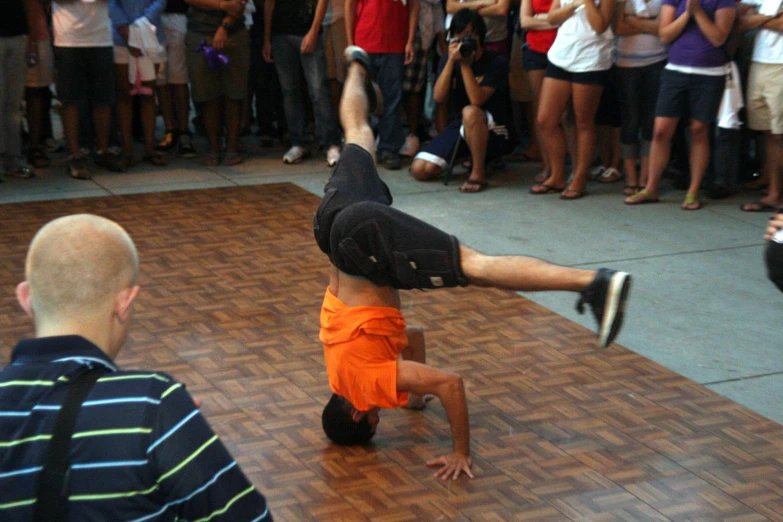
left=0, top=0, right=783, bottom=211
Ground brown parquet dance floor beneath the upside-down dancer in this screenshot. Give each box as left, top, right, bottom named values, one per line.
left=0, top=184, right=783, bottom=522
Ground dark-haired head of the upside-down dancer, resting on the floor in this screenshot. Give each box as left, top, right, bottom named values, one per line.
left=321, top=394, right=380, bottom=446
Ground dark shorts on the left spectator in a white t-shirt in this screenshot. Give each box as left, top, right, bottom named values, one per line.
left=54, top=46, right=115, bottom=107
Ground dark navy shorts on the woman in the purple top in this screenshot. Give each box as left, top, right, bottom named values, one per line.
left=655, top=69, right=726, bottom=123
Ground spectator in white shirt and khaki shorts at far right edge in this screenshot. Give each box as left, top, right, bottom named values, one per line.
left=740, top=5, right=783, bottom=211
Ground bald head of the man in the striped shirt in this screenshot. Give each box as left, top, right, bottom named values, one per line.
left=17, top=214, right=139, bottom=357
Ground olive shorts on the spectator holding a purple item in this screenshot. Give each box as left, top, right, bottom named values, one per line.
left=185, top=29, right=250, bottom=103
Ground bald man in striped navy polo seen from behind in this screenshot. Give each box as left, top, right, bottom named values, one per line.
left=0, top=214, right=272, bottom=521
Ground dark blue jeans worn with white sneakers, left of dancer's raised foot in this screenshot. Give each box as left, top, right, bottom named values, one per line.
left=272, top=34, right=340, bottom=147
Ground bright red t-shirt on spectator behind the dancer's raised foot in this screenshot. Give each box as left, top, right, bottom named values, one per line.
left=353, top=0, right=408, bottom=53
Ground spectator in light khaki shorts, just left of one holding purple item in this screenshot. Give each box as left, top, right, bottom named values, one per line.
left=156, top=0, right=196, bottom=158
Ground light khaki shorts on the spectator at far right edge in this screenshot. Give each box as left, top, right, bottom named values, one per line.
left=747, top=62, right=783, bottom=134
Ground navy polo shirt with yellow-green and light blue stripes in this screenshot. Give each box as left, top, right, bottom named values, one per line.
left=0, top=336, right=272, bottom=522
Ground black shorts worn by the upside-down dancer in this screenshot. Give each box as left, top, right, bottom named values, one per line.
left=313, top=144, right=468, bottom=290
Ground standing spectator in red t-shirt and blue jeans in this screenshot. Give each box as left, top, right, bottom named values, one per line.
left=345, top=0, right=419, bottom=170
